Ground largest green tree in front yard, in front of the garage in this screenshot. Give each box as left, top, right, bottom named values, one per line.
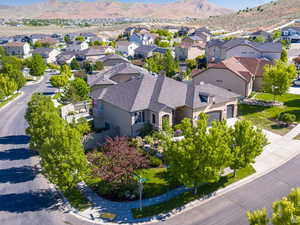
left=165, top=113, right=230, bottom=193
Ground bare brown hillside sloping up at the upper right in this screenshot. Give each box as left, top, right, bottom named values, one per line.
left=194, top=0, right=300, bottom=31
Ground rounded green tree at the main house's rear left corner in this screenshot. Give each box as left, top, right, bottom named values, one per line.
left=63, top=78, right=90, bottom=102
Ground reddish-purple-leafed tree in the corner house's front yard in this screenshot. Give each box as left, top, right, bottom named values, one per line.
left=88, top=137, right=148, bottom=187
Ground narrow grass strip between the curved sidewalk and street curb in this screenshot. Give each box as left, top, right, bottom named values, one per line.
left=132, top=166, right=255, bottom=218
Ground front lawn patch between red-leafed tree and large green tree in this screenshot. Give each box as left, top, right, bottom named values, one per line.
left=137, top=168, right=179, bottom=198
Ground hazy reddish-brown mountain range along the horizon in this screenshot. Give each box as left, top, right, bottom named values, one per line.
left=0, top=0, right=233, bottom=19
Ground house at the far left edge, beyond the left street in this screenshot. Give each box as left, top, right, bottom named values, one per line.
left=2, top=42, right=30, bottom=58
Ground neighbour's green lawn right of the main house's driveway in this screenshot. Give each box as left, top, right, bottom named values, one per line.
left=238, top=93, right=300, bottom=135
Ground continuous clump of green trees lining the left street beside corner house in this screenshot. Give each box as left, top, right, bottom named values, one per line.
left=25, top=94, right=89, bottom=191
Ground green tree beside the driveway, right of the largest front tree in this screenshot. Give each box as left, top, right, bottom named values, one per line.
left=229, top=120, right=267, bottom=176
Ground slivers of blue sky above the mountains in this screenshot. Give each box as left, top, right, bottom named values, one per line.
left=0, top=0, right=271, bottom=9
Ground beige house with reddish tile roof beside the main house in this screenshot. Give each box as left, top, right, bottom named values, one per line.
left=193, top=57, right=272, bottom=97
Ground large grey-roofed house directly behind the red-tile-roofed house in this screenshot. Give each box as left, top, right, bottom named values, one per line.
left=205, top=38, right=282, bottom=62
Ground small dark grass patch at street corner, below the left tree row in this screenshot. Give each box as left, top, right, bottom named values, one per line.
left=64, top=188, right=92, bottom=211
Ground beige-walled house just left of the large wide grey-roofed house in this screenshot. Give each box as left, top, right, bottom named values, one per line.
left=175, top=43, right=205, bottom=61
